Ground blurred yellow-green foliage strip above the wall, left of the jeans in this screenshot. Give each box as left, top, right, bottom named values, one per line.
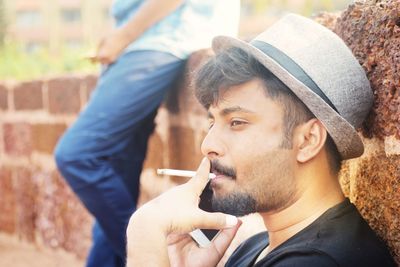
left=0, top=42, right=98, bottom=80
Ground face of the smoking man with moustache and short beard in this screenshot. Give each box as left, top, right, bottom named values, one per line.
left=201, top=79, right=296, bottom=216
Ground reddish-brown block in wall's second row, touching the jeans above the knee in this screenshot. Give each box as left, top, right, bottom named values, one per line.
left=31, top=123, right=67, bottom=154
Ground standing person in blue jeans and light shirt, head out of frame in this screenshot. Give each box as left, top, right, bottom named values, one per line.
left=55, top=0, right=240, bottom=267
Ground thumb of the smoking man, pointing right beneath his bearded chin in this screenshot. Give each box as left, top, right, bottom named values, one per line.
left=195, top=210, right=239, bottom=229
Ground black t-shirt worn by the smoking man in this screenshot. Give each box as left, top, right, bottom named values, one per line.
left=225, top=199, right=396, bottom=267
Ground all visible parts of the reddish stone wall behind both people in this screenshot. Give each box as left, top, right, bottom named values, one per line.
left=0, top=1, right=400, bottom=264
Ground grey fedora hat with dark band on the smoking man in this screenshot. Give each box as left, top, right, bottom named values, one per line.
left=212, top=14, right=373, bottom=159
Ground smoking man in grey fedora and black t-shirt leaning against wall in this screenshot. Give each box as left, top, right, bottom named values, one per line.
left=127, top=15, right=394, bottom=266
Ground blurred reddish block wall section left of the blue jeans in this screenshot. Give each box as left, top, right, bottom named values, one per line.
left=0, top=76, right=96, bottom=257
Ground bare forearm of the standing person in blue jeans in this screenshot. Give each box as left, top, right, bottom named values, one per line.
left=93, top=0, right=184, bottom=64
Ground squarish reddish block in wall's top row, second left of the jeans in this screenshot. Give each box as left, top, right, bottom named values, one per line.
left=48, top=77, right=81, bottom=114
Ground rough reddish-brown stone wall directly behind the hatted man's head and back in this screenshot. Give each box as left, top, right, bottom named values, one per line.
left=317, top=0, right=400, bottom=265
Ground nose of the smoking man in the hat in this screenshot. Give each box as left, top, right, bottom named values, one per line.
left=201, top=127, right=226, bottom=159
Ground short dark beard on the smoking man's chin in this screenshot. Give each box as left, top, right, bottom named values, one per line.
left=211, top=192, right=257, bottom=217
